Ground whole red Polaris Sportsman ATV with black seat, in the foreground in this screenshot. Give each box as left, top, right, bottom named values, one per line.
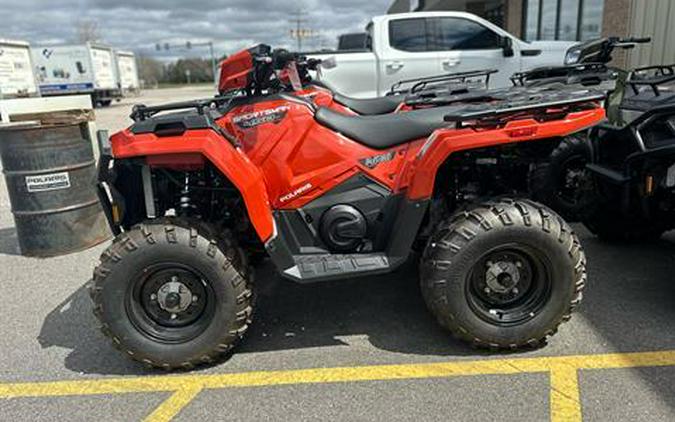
left=91, top=46, right=604, bottom=369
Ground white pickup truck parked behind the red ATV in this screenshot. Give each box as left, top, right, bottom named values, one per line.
left=310, top=12, right=575, bottom=98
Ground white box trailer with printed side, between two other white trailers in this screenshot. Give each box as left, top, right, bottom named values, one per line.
left=32, top=43, right=122, bottom=106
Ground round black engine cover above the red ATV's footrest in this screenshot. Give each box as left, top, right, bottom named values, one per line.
left=319, top=204, right=368, bottom=252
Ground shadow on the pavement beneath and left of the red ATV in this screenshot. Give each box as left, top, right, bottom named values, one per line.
left=38, top=258, right=481, bottom=375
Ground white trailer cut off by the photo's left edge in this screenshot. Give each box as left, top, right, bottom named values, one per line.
left=0, top=38, right=39, bottom=99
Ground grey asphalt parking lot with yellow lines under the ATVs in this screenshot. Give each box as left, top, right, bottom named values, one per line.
left=0, top=87, right=675, bottom=421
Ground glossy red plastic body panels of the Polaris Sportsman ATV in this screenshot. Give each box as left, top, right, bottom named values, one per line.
left=107, top=96, right=605, bottom=242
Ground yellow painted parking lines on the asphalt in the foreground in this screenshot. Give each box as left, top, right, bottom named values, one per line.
left=0, top=351, right=675, bottom=422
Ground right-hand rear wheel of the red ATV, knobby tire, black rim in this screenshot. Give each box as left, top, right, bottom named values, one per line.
left=420, top=199, right=586, bottom=350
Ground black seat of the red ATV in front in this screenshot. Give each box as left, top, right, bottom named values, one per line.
left=314, top=107, right=454, bottom=149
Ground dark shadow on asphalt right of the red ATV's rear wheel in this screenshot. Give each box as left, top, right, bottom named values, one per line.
left=580, top=229, right=675, bottom=409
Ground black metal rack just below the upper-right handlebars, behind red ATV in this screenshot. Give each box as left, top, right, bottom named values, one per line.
left=511, top=63, right=609, bottom=86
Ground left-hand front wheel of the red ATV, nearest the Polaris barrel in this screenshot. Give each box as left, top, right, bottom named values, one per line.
left=90, top=220, right=253, bottom=369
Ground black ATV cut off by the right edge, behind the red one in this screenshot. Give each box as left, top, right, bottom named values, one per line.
left=582, top=65, right=675, bottom=240
